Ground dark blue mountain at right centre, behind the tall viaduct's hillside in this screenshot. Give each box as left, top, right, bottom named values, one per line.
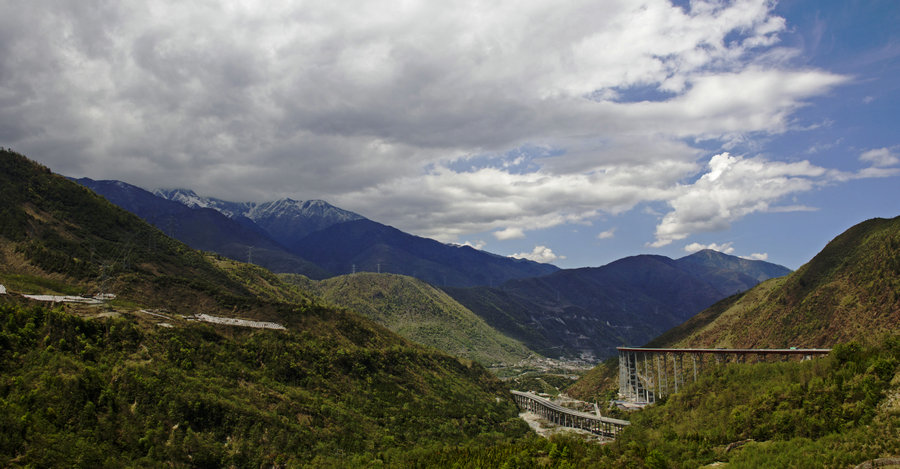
left=445, top=251, right=790, bottom=358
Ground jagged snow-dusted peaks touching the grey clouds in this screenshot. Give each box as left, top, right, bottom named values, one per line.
left=155, top=189, right=365, bottom=247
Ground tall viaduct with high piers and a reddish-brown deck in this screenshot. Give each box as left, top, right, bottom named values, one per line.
left=617, top=347, right=831, bottom=404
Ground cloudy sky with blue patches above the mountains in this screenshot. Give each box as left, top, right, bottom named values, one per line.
left=0, top=0, right=900, bottom=269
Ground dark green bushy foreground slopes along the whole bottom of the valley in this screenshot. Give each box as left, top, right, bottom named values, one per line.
left=0, top=298, right=900, bottom=468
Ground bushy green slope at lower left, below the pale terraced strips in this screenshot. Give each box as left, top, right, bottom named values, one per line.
left=0, top=305, right=526, bottom=467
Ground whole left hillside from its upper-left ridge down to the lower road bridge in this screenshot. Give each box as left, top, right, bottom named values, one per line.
left=0, top=150, right=527, bottom=467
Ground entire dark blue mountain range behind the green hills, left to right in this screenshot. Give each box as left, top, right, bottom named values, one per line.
left=77, top=175, right=790, bottom=363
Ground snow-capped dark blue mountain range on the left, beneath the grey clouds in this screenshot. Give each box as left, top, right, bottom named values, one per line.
left=77, top=179, right=559, bottom=286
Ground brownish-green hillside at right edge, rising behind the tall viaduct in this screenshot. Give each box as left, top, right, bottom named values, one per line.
left=651, top=217, right=900, bottom=347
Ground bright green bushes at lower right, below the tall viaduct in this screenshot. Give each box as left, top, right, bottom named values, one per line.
left=416, top=335, right=900, bottom=468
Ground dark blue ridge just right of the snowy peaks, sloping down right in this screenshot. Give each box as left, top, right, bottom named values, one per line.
left=292, top=219, right=559, bottom=286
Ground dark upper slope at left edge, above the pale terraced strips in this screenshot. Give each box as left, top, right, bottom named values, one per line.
left=0, top=150, right=320, bottom=318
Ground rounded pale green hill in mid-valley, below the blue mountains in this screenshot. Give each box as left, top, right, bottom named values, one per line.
left=282, top=273, right=532, bottom=366
